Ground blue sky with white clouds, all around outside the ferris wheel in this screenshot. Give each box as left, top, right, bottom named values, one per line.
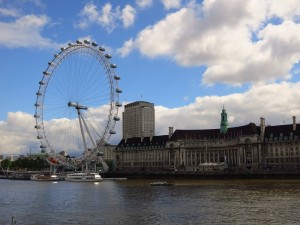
left=0, top=0, right=300, bottom=154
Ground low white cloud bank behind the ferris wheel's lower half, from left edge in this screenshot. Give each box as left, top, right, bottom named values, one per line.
left=0, top=105, right=122, bottom=155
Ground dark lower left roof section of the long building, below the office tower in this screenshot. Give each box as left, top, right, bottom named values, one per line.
left=117, top=135, right=169, bottom=148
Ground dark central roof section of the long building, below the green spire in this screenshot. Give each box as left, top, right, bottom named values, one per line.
left=170, top=123, right=259, bottom=141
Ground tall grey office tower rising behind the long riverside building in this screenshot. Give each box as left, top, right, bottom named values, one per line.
left=123, top=101, right=155, bottom=139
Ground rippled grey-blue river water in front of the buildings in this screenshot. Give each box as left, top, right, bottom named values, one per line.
left=0, top=179, right=300, bottom=225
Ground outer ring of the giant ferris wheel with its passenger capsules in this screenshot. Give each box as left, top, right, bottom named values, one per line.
left=34, top=40, right=122, bottom=165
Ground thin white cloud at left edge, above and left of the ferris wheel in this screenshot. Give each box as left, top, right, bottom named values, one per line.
left=0, top=15, right=60, bottom=48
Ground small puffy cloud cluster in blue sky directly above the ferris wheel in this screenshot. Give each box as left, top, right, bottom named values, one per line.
left=76, top=2, right=136, bottom=32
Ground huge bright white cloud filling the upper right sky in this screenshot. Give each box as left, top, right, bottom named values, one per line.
left=120, top=0, right=300, bottom=85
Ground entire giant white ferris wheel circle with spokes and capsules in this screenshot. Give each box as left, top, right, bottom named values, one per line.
left=34, top=40, right=122, bottom=166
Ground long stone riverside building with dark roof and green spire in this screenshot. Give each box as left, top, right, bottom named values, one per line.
left=116, top=108, right=300, bottom=174
